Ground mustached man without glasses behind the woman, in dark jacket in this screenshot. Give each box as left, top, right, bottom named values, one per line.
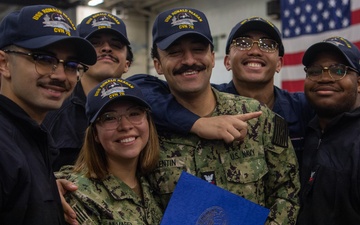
left=43, top=12, right=133, bottom=171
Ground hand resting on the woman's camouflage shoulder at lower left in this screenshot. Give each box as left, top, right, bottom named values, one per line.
left=56, top=179, right=78, bottom=225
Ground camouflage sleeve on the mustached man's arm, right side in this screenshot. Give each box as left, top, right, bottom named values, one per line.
left=262, top=109, right=300, bottom=225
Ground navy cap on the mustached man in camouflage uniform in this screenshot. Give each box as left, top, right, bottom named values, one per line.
left=152, top=7, right=214, bottom=50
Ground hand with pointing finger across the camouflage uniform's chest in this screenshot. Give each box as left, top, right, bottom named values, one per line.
left=191, top=111, right=262, bottom=143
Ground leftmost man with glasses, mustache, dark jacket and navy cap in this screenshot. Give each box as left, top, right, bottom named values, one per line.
left=0, top=5, right=96, bottom=225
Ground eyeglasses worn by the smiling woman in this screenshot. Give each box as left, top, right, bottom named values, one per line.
left=96, top=107, right=149, bottom=130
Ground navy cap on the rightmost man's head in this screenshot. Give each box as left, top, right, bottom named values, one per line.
left=302, top=37, right=360, bottom=72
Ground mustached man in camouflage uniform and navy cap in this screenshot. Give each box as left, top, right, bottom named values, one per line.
left=145, top=7, right=300, bottom=224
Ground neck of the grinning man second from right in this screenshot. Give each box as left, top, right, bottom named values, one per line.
left=234, top=80, right=275, bottom=109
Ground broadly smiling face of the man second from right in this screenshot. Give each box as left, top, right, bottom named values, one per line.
left=224, top=31, right=282, bottom=85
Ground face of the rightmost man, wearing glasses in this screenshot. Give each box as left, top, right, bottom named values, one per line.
left=304, top=52, right=360, bottom=118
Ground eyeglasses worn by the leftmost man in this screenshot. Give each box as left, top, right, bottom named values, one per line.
left=3, top=50, right=89, bottom=76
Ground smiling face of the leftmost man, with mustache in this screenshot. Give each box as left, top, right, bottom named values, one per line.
left=0, top=44, right=77, bottom=122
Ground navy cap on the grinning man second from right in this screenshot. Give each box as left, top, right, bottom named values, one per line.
left=225, top=17, right=285, bottom=56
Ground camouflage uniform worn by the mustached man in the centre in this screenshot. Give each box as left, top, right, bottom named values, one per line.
left=150, top=89, right=300, bottom=224
